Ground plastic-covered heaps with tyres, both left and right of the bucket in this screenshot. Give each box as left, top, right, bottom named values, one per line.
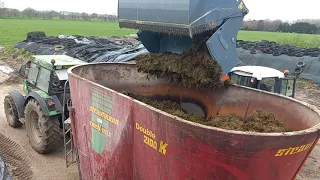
left=15, top=32, right=320, bottom=84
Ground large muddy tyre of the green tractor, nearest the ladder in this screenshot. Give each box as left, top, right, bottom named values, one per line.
left=25, top=99, right=60, bottom=154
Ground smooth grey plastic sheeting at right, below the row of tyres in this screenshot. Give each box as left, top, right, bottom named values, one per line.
left=237, top=48, right=320, bottom=84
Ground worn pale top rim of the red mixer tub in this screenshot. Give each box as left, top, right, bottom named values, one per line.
left=67, top=62, right=320, bottom=138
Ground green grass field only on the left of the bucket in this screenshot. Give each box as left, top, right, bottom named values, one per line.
left=0, top=19, right=137, bottom=45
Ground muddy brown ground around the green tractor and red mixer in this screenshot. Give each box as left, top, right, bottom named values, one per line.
left=0, top=48, right=320, bottom=180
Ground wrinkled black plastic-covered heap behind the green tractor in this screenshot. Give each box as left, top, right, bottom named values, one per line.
left=15, top=34, right=148, bottom=62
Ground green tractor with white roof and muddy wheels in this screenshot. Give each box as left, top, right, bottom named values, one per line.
left=4, top=55, right=86, bottom=154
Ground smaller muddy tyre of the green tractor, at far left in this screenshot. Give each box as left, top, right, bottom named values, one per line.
left=3, top=95, right=23, bottom=128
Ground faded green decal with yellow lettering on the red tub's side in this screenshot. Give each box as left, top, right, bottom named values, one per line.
left=90, top=89, right=115, bottom=154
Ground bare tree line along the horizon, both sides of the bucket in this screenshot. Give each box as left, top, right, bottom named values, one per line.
left=0, top=0, right=320, bottom=34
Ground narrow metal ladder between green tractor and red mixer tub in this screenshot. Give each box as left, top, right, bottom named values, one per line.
left=62, top=81, right=77, bottom=168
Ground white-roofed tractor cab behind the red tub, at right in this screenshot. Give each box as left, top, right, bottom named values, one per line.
left=228, top=66, right=296, bottom=98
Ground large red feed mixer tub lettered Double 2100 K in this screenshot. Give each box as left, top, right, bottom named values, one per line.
left=68, top=63, right=320, bottom=180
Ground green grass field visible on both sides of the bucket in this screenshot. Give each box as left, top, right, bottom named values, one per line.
left=0, top=19, right=320, bottom=47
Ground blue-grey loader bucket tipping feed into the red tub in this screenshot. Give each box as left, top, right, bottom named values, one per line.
left=118, top=0, right=249, bottom=74
